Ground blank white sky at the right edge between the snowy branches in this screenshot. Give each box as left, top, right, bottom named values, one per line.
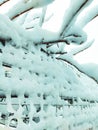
left=75, top=18, right=98, bottom=64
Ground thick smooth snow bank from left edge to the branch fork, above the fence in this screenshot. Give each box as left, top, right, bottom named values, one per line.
left=0, top=15, right=58, bottom=46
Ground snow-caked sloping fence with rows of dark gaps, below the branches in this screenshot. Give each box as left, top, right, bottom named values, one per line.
left=0, top=28, right=98, bottom=130
